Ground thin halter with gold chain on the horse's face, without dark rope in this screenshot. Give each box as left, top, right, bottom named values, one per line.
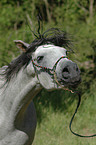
left=32, top=56, right=74, bottom=93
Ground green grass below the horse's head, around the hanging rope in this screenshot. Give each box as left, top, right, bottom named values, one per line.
left=34, top=85, right=96, bottom=145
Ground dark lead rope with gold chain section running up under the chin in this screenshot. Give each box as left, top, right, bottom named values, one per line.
left=54, top=71, right=96, bottom=138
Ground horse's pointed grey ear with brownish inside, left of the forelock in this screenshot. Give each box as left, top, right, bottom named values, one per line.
left=14, top=40, right=29, bottom=52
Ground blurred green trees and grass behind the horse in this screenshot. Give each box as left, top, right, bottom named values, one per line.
left=0, top=0, right=96, bottom=145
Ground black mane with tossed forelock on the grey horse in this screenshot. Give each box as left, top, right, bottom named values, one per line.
left=3, top=28, right=72, bottom=82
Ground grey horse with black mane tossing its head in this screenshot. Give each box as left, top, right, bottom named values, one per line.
left=0, top=28, right=81, bottom=145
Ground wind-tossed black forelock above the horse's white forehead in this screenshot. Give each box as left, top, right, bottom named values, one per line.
left=27, top=28, right=72, bottom=52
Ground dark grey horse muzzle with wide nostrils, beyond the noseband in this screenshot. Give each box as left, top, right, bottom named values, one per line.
left=56, top=60, right=81, bottom=88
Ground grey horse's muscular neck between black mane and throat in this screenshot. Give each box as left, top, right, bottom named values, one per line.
left=0, top=65, right=41, bottom=118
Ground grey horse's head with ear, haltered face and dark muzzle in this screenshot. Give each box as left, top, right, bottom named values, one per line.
left=15, top=29, right=81, bottom=90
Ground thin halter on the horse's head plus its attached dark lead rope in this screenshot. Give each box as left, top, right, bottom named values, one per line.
left=32, top=56, right=96, bottom=138
